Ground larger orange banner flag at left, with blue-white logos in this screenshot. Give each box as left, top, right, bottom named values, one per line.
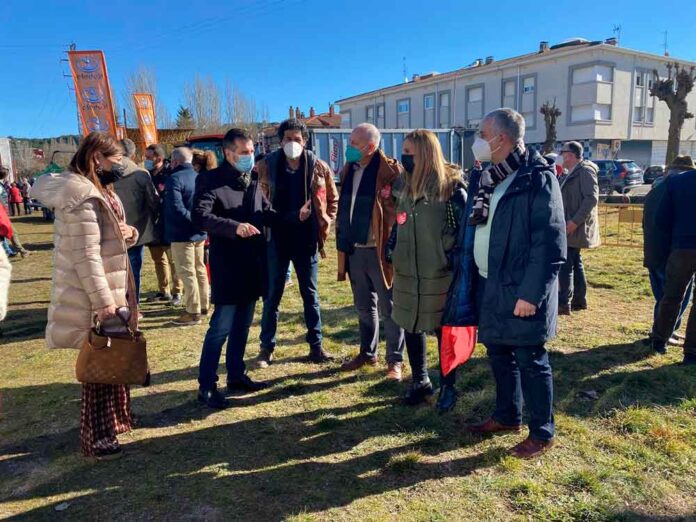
left=68, top=51, right=116, bottom=137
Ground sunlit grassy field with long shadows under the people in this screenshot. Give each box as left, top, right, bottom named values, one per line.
left=0, top=213, right=696, bottom=522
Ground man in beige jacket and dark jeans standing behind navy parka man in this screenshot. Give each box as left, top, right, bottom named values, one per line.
left=557, top=141, right=599, bottom=315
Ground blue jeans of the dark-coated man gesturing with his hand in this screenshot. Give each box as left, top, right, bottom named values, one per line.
left=198, top=301, right=256, bottom=389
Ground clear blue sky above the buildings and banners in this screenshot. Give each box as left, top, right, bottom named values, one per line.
left=0, top=0, right=696, bottom=137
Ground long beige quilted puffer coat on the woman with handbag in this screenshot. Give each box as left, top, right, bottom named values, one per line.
left=32, top=172, right=138, bottom=348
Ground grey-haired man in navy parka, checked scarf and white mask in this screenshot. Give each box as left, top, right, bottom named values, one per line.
left=443, top=109, right=567, bottom=458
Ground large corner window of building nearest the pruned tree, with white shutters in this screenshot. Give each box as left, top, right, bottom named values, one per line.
left=568, top=62, right=614, bottom=123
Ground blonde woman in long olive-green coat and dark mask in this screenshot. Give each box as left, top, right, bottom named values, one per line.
left=387, top=129, right=466, bottom=413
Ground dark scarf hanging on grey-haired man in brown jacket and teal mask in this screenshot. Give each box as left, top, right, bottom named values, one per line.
left=336, top=154, right=380, bottom=254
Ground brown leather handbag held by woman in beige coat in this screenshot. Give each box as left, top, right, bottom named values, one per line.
left=75, top=307, right=150, bottom=386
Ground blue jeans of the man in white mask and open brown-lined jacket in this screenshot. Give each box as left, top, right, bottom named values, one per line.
left=261, top=241, right=322, bottom=352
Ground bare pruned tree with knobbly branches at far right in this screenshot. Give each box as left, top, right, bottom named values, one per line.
left=650, top=62, right=696, bottom=165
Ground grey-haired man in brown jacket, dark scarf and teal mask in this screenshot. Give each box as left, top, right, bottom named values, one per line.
left=336, top=123, right=404, bottom=381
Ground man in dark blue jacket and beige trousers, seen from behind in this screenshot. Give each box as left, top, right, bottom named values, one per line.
left=162, top=147, right=210, bottom=326
